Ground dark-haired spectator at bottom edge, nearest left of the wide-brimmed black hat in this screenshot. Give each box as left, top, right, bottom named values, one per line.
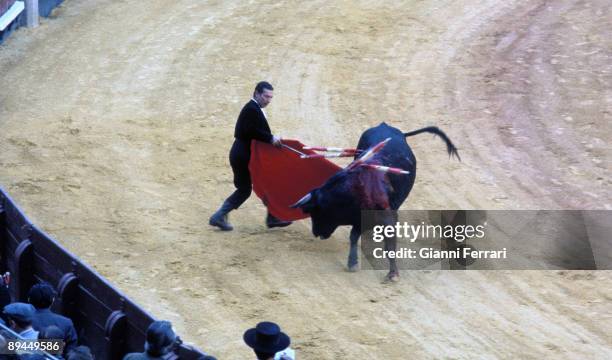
left=123, top=321, right=178, bottom=360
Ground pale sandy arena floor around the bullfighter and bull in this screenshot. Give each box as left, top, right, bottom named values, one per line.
left=0, top=0, right=612, bottom=359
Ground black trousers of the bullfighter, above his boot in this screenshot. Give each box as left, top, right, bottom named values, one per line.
left=225, top=139, right=253, bottom=210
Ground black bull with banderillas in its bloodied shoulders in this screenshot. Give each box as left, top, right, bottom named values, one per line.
left=292, top=123, right=459, bottom=280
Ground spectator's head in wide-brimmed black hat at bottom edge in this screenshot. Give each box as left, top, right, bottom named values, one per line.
left=243, top=321, right=291, bottom=360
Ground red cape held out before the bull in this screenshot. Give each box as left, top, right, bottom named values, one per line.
left=249, top=139, right=341, bottom=221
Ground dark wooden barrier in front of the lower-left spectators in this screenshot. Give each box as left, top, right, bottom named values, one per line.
left=0, top=188, right=204, bottom=360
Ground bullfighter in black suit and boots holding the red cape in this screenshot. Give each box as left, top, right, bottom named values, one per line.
left=208, top=81, right=291, bottom=231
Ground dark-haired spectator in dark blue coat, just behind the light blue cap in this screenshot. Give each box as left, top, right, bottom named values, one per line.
left=28, top=282, right=77, bottom=355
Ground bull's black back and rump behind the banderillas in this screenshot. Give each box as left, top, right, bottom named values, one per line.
left=357, top=122, right=416, bottom=210
